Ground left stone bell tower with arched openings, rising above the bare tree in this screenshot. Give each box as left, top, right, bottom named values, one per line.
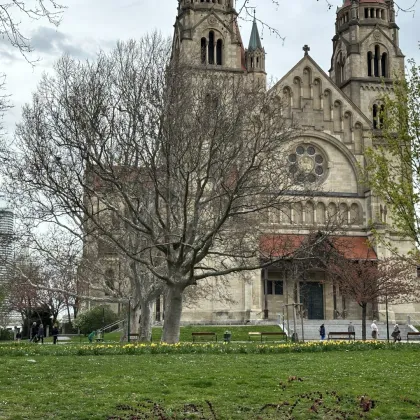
left=172, top=0, right=246, bottom=73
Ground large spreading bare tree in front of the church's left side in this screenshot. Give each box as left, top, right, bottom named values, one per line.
left=3, top=34, right=322, bottom=342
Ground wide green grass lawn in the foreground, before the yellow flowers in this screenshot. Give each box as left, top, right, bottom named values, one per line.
left=0, top=348, right=420, bottom=420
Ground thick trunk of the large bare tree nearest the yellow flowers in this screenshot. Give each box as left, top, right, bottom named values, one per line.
left=162, top=285, right=184, bottom=344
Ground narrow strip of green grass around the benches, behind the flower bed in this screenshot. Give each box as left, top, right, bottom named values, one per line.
left=49, top=325, right=282, bottom=343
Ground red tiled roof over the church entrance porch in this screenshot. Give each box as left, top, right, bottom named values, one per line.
left=260, top=234, right=378, bottom=260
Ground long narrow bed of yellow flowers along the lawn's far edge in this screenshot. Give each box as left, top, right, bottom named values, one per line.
left=0, top=341, right=420, bottom=357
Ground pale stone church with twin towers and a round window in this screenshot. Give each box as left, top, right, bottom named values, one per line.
left=173, top=0, right=418, bottom=323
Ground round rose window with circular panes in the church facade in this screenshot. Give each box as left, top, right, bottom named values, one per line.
left=288, top=144, right=327, bottom=184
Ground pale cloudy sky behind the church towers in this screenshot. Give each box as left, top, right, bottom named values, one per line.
left=0, top=0, right=420, bottom=135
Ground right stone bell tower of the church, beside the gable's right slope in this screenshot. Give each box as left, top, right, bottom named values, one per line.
left=330, top=0, right=404, bottom=124
